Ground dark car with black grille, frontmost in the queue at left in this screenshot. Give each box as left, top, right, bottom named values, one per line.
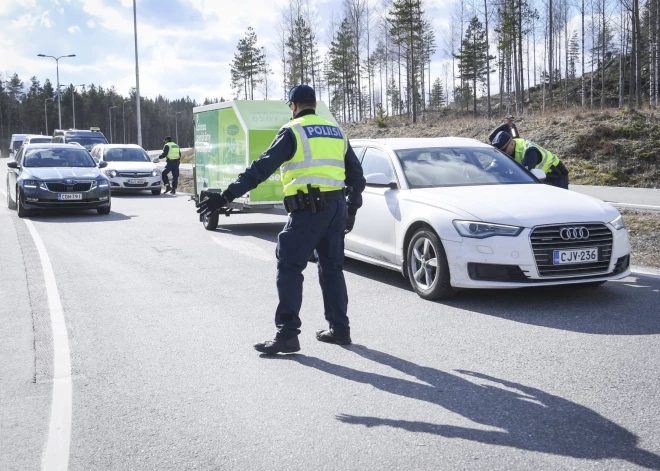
left=7, top=144, right=111, bottom=217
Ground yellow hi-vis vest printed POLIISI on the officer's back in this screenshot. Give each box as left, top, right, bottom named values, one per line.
left=280, top=114, right=348, bottom=196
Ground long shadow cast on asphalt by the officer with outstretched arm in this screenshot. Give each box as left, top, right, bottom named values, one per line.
left=288, top=345, right=660, bottom=469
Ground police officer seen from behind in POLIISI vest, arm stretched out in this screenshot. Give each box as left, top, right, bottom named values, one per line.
left=197, top=85, right=365, bottom=354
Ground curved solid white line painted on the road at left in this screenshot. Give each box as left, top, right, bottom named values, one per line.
left=25, top=220, right=72, bottom=471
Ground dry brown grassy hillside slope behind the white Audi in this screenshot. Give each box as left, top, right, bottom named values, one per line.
left=342, top=109, right=660, bottom=188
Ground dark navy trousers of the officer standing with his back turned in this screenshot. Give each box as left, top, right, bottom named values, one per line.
left=275, top=199, right=350, bottom=340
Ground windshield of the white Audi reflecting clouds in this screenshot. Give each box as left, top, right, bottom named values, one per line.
left=396, top=147, right=536, bottom=188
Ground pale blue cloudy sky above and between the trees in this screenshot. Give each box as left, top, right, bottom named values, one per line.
left=0, top=0, right=453, bottom=101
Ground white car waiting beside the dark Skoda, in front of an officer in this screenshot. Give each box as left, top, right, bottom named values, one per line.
left=91, top=144, right=162, bottom=195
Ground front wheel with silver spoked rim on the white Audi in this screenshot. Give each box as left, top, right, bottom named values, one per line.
left=406, top=228, right=455, bottom=300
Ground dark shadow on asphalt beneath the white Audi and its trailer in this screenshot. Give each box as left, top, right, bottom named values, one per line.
left=211, top=224, right=660, bottom=335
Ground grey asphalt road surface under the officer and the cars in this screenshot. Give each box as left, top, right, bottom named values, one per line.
left=0, top=160, right=660, bottom=470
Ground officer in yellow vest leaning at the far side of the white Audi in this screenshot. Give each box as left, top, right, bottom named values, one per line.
left=493, top=131, right=568, bottom=190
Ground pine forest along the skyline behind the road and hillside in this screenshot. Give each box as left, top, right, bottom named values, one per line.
left=0, top=0, right=660, bottom=152
